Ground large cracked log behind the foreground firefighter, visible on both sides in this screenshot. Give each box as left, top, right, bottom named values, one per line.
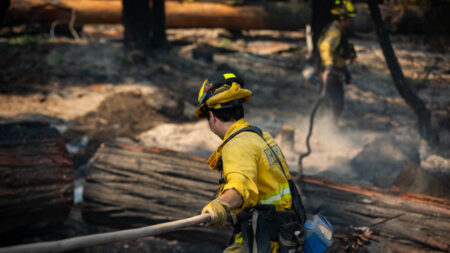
left=83, top=142, right=450, bottom=251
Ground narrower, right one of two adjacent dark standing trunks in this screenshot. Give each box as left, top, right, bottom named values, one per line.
left=152, top=0, right=167, bottom=48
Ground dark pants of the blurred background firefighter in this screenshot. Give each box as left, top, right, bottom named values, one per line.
left=325, top=71, right=344, bottom=122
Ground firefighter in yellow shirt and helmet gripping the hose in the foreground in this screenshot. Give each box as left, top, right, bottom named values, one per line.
left=195, top=72, right=304, bottom=252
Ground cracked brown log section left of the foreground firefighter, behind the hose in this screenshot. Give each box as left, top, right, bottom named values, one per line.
left=82, top=142, right=231, bottom=246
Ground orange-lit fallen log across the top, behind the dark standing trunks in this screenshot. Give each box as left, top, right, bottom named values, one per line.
left=5, top=0, right=310, bottom=30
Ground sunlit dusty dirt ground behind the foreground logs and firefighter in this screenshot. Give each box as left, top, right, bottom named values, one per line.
left=0, top=26, right=450, bottom=252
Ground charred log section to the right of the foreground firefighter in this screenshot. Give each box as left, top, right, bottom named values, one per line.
left=301, top=177, right=450, bottom=252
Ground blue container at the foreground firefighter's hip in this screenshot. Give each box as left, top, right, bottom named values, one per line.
left=304, top=215, right=334, bottom=253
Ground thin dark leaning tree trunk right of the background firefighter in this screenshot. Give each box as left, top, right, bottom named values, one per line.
left=367, top=0, right=432, bottom=141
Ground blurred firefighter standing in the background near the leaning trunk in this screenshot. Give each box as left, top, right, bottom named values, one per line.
left=318, top=0, right=356, bottom=121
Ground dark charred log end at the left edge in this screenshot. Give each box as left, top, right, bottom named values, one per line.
left=0, top=122, right=74, bottom=244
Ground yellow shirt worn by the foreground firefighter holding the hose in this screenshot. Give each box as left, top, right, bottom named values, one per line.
left=208, top=119, right=292, bottom=213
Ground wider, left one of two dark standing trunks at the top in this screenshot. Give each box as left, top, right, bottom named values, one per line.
left=122, top=0, right=151, bottom=52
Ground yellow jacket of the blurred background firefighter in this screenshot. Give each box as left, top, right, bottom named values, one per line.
left=318, top=20, right=347, bottom=69
